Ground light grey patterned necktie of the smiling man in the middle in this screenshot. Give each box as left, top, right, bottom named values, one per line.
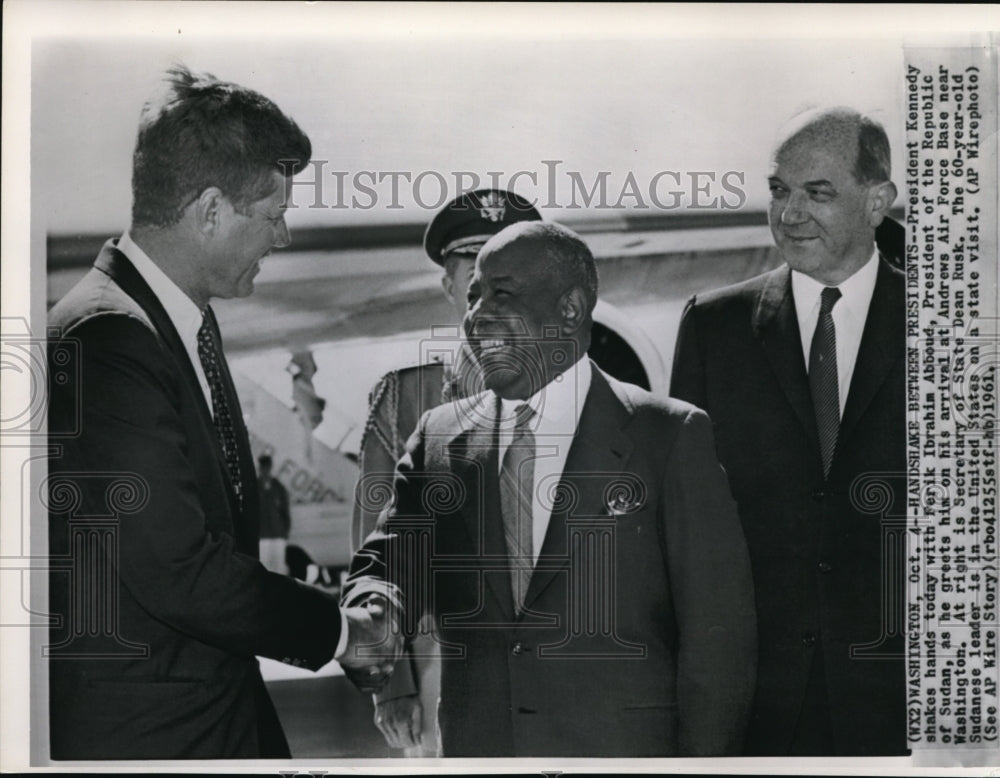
left=500, top=404, right=535, bottom=613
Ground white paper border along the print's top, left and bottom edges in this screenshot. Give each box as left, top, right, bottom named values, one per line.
left=7, top=0, right=1000, bottom=775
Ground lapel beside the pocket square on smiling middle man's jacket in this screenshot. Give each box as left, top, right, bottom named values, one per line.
left=524, top=363, right=632, bottom=608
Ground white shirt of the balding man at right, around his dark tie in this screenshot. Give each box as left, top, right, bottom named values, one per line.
left=792, top=250, right=879, bottom=417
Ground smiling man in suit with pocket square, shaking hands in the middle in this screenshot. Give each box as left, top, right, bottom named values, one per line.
left=344, top=222, right=755, bottom=757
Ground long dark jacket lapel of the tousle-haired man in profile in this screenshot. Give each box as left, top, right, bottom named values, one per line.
left=94, top=241, right=242, bottom=516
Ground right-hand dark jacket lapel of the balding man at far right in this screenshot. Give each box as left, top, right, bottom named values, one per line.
left=834, top=259, right=906, bottom=454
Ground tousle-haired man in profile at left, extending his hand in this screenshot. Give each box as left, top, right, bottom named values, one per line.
left=47, top=67, right=398, bottom=759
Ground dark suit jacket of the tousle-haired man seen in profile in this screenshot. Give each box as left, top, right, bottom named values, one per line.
left=48, top=241, right=340, bottom=759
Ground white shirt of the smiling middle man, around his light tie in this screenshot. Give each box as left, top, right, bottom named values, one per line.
left=498, top=354, right=591, bottom=563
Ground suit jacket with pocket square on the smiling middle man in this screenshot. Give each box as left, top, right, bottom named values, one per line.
left=345, top=367, right=756, bottom=756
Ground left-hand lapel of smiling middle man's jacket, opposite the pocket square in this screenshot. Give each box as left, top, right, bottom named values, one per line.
left=447, top=392, right=514, bottom=621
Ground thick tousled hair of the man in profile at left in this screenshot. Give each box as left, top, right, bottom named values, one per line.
left=132, top=65, right=312, bottom=227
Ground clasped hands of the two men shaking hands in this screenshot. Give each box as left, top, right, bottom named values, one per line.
left=337, top=594, right=403, bottom=692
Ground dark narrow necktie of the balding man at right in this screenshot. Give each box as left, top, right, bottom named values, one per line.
left=809, top=286, right=840, bottom=478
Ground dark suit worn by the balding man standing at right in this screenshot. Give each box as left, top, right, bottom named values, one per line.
left=671, top=261, right=906, bottom=755
